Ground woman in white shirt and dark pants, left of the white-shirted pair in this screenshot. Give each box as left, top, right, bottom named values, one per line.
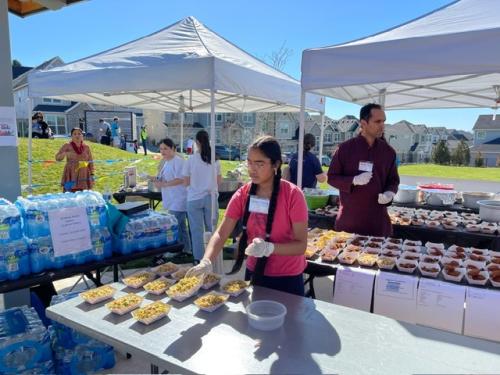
left=155, top=138, right=191, bottom=253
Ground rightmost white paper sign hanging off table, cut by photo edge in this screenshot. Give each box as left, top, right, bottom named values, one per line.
left=464, top=287, right=500, bottom=341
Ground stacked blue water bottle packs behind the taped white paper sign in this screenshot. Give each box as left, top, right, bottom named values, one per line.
left=16, top=191, right=112, bottom=273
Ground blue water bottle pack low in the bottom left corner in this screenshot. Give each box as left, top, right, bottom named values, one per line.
left=0, top=306, right=54, bottom=375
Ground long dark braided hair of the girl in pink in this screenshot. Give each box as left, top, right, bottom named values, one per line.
left=229, top=136, right=282, bottom=285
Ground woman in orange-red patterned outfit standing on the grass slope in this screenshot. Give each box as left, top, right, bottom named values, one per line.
left=56, top=128, right=94, bottom=192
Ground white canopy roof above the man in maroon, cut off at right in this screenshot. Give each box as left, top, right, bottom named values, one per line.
left=302, top=0, right=500, bottom=109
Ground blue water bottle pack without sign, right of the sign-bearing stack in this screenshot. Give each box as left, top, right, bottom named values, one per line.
left=114, top=210, right=179, bottom=254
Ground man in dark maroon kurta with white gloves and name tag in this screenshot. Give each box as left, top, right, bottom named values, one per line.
left=328, top=103, right=399, bottom=237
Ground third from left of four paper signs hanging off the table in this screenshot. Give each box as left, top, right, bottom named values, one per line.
left=417, top=278, right=465, bottom=334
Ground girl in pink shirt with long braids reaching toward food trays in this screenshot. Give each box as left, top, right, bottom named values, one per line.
left=188, top=136, right=307, bottom=295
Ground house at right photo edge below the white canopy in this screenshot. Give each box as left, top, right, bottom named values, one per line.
left=471, top=115, right=500, bottom=167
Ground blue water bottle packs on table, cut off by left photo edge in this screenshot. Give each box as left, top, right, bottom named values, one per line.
left=0, top=198, right=31, bottom=281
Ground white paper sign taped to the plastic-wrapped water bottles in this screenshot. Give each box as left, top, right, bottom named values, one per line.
left=49, top=207, right=92, bottom=257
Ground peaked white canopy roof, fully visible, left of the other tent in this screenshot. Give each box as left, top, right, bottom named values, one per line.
left=28, top=17, right=324, bottom=112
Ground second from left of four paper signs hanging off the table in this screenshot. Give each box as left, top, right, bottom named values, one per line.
left=373, top=271, right=418, bottom=324
